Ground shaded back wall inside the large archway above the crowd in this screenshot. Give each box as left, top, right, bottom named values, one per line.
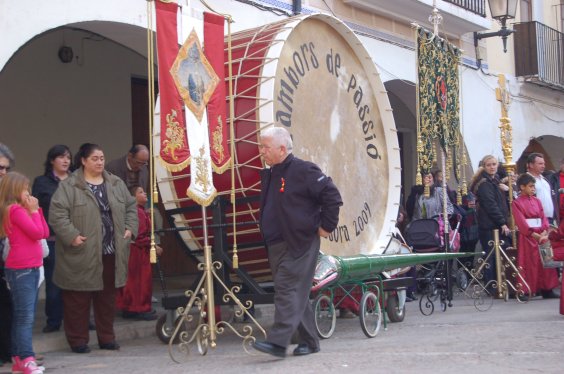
left=0, top=30, right=147, bottom=177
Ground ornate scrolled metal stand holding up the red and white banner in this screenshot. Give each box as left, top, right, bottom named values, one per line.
left=168, top=207, right=266, bottom=362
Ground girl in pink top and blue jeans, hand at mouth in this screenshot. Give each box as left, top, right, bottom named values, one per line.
left=0, top=172, right=49, bottom=374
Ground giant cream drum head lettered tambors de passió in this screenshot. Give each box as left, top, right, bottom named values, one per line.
left=260, top=15, right=400, bottom=256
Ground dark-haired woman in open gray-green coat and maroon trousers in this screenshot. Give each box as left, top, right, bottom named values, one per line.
left=49, top=143, right=138, bottom=353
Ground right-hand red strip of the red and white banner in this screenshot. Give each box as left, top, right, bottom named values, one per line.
left=204, top=12, right=231, bottom=174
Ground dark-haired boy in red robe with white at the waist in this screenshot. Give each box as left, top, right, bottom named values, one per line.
left=512, top=174, right=559, bottom=299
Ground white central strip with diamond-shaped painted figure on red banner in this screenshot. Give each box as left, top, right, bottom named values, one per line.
left=170, top=30, right=219, bottom=206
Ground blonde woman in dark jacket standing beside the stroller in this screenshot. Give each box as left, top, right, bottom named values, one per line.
left=470, top=155, right=511, bottom=283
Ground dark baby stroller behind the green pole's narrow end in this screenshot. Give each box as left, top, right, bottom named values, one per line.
left=405, top=214, right=467, bottom=316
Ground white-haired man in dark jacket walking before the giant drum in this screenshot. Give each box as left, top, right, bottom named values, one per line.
left=254, top=127, right=343, bottom=357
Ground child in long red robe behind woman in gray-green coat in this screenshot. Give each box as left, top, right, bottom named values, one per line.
left=116, top=186, right=162, bottom=321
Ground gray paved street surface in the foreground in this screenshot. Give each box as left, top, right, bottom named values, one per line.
left=0, top=295, right=564, bottom=374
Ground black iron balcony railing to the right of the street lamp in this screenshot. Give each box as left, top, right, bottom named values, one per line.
left=513, top=21, right=564, bottom=89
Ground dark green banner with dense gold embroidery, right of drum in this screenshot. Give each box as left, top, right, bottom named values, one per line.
left=417, top=27, right=460, bottom=179
